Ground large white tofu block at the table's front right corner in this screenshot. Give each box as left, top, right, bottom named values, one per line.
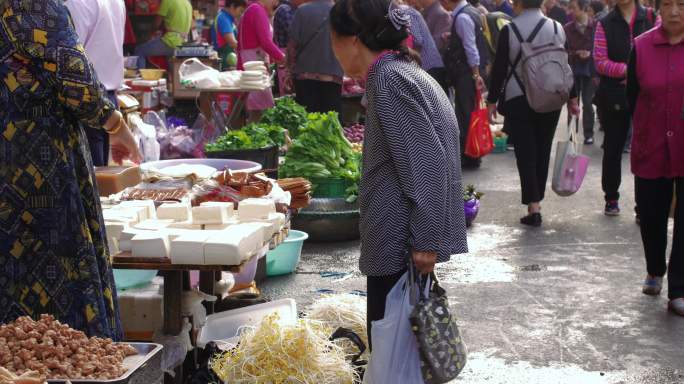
left=204, top=224, right=264, bottom=265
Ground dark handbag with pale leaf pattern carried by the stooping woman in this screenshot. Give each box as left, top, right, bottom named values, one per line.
left=409, top=263, right=467, bottom=384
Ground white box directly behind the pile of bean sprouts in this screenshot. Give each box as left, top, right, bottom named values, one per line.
left=197, top=299, right=297, bottom=348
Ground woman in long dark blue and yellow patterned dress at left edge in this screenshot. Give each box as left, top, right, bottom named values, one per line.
left=0, top=0, right=140, bottom=340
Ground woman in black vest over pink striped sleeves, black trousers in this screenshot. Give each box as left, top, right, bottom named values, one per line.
left=594, top=0, right=656, bottom=216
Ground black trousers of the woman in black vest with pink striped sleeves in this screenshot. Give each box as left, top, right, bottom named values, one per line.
left=599, top=107, right=638, bottom=201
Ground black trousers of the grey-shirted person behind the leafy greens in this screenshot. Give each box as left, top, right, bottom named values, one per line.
left=294, top=80, right=342, bottom=113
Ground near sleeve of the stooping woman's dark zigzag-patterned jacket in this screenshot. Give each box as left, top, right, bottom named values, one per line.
left=376, top=79, right=448, bottom=252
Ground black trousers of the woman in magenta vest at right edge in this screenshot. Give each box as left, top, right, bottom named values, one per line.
left=635, top=177, right=684, bottom=299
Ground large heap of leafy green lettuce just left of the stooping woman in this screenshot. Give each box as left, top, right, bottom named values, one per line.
left=280, top=112, right=361, bottom=202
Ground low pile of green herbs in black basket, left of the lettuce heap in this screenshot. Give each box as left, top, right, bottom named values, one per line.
left=204, top=123, right=285, bottom=152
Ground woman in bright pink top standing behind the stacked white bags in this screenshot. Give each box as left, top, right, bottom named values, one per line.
left=238, top=0, right=285, bottom=120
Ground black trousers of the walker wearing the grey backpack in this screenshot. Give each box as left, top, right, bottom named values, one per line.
left=505, top=96, right=561, bottom=205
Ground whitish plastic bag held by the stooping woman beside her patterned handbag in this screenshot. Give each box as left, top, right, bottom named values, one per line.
left=363, top=272, right=423, bottom=384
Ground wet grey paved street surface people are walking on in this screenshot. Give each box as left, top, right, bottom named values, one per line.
left=262, top=121, right=684, bottom=384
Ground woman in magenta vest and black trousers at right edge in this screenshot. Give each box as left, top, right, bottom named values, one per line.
left=627, top=0, right=684, bottom=316
